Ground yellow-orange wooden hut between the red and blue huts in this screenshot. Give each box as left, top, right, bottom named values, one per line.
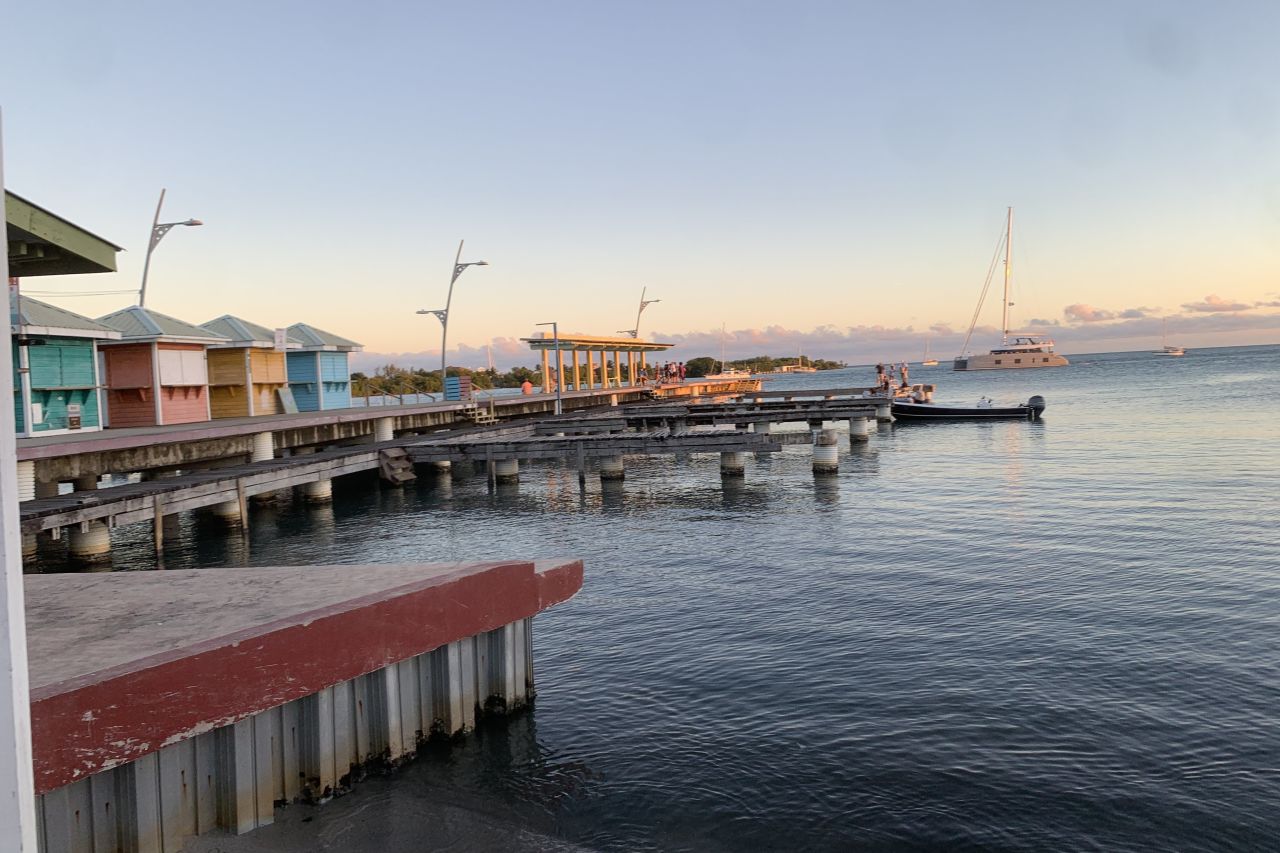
left=201, top=314, right=300, bottom=418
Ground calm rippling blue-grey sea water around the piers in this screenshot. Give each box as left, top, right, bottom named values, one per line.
left=74, top=347, right=1280, bottom=853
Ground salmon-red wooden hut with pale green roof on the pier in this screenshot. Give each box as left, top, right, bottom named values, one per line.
left=97, top=305, right=227, bottom=427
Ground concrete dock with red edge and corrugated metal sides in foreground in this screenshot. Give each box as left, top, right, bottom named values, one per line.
left=27, top=561, right=582, bottom=853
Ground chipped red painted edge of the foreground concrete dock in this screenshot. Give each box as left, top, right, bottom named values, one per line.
left=31, top=561, right=582, bottom=794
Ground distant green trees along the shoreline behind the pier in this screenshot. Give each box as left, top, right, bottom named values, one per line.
left=351, top=355, right=849, bottom=397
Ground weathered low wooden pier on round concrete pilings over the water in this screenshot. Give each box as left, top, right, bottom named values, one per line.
left=20, top=392, right=888, bottom=562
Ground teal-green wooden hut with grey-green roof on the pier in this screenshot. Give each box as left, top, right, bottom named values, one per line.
left=13, top=296, right=120, bottom=438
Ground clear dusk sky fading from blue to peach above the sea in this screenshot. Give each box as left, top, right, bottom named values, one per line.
left=0, top=0, right=1280, bottom=366
